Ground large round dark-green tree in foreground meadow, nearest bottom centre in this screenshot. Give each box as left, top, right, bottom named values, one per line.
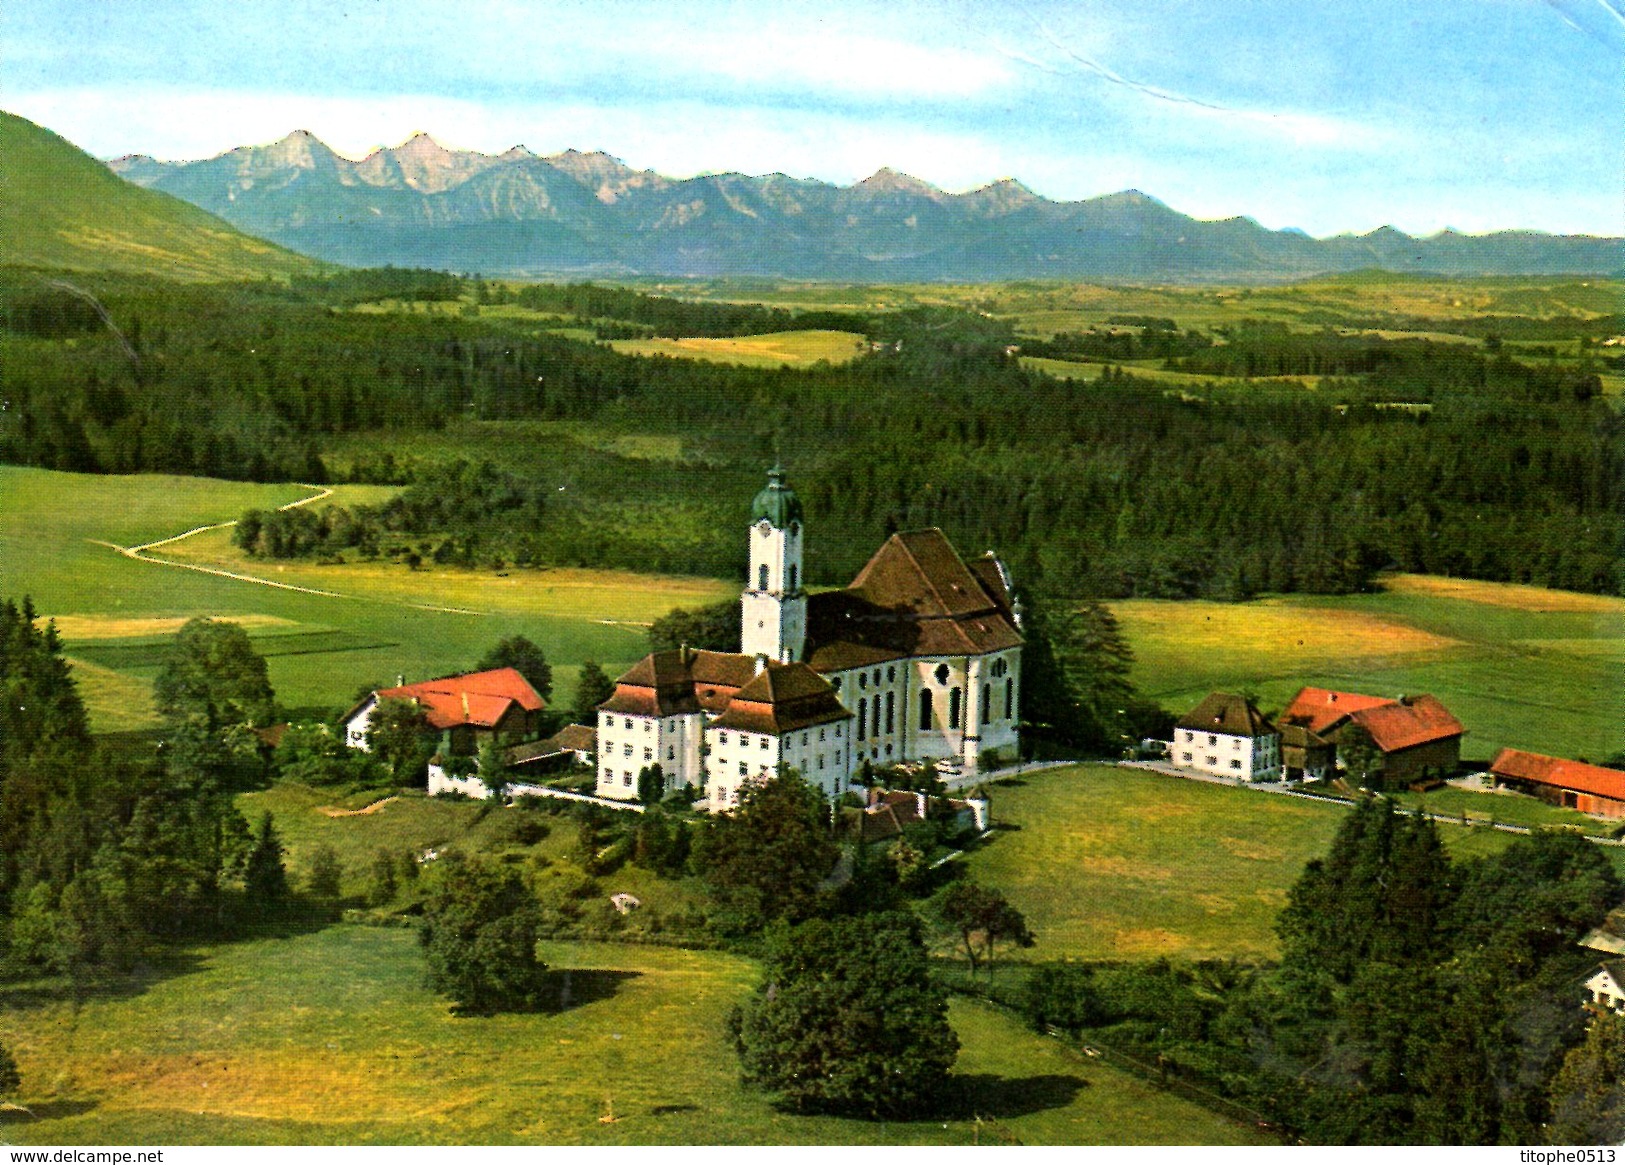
left=730, top=913, right=959, bottom=1116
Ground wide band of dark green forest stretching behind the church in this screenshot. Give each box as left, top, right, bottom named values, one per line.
left=0, top=271, right=1625, bottom=596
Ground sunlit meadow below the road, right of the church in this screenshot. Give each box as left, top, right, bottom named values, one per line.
left=944, top=765, right=1605, bottom=960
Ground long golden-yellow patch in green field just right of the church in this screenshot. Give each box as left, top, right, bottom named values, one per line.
left=1112, top=600, right=1461, bottom=663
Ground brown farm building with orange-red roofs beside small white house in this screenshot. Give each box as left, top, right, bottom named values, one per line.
left=1281, top=687, right=1466, bottom=782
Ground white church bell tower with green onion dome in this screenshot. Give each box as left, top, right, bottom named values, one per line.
left=739, top=465, right=808, bottom=663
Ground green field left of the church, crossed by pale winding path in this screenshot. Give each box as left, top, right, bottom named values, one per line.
left=0, top=466, right=735, bottom=731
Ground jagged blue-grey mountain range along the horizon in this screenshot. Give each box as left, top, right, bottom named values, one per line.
left=112, top=132, right=1625, bottom=281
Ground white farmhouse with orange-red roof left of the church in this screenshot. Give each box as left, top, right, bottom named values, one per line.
left=345, top=668, right=546, bottom=776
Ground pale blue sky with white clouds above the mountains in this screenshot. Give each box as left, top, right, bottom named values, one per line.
left=0, top=0, right=1625, bottom=236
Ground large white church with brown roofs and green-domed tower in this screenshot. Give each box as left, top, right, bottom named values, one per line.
left=596, top=466, right=1022, bottom=811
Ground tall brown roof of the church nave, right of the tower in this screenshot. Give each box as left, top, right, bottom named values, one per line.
left=808, top=528, right=1022, bottom=671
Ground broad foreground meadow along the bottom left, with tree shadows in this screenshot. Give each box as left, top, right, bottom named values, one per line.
left=0, top=926, right=1259, bottom=1146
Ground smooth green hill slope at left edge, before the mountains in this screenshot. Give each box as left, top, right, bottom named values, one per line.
left=0, top=112, right=322, bottom=279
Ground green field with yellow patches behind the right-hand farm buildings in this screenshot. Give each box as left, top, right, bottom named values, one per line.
left=1112, top=575, right=1625, bottom=762
